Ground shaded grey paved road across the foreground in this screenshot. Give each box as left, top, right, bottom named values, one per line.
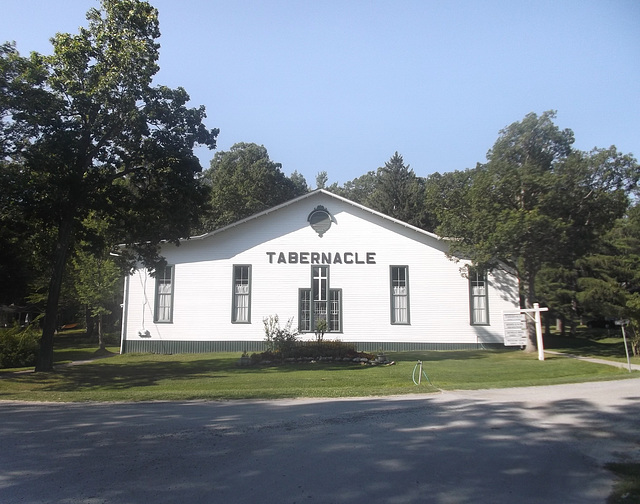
left=0, top=379, right=640, bottom=504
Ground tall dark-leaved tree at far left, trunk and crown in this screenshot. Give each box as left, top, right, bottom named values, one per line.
left=0, top=0, right=218, bottom=371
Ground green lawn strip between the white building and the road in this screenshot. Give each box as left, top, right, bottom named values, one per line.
left=0, top=326, right=629, bottom=401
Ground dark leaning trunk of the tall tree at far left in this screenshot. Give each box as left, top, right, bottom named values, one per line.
left=35, top=218, right=73, bottom=372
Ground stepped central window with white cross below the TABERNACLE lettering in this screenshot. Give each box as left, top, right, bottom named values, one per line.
left=298, top=266, right=342, bottom=332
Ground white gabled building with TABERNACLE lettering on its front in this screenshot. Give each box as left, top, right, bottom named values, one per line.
left=121, top=190, right=519, bottom=353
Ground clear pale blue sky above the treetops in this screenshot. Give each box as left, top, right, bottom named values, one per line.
left=0, top=0, right=640, bottom=187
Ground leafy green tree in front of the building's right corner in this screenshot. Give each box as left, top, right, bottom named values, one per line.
left=429, top=112, right=639, bottom=350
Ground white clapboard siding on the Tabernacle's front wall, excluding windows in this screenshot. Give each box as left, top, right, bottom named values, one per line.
left=123, top=191, right=518, bottom=344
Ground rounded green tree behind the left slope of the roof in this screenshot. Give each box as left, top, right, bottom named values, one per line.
left=204, top=143, right=307, bottom=231
